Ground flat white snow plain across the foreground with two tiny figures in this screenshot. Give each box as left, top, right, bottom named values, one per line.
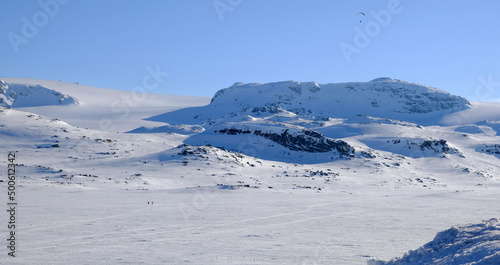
left=0, top=184, right=498, bottom=264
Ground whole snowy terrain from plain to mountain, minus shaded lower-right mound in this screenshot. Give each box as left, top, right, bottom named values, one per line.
left=0, top=78, right=500, bottom=264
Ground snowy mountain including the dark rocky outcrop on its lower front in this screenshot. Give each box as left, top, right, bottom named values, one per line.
left=135, top=78, right=490, bottom=163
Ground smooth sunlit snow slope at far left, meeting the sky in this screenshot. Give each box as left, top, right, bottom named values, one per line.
left=0, top=78, right=210, bottom=132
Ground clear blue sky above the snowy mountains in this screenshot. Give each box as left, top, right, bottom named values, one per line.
left=0, top=0, right=500, bottom=101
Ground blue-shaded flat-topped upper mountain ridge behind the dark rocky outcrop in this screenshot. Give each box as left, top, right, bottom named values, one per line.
left=151, top=78, right=470, bottom=124
